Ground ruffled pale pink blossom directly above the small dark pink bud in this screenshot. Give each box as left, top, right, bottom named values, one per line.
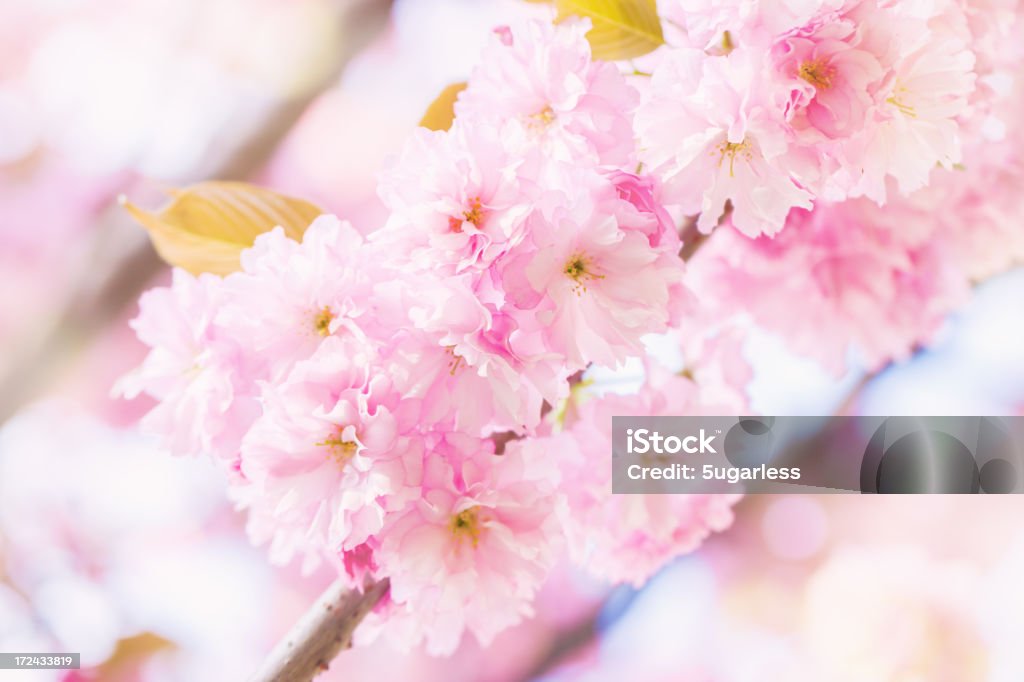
left=242, top=337, right=422, bottom=552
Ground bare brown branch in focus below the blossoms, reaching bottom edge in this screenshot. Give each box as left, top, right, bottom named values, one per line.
left=249, top=579, right=389, bottom=682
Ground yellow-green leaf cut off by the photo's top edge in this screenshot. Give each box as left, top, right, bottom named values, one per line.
left=555, top=0, right=665, bottom=60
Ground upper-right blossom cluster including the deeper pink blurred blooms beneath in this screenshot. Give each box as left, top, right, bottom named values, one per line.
left=647, top=0, right=1024, bottom=374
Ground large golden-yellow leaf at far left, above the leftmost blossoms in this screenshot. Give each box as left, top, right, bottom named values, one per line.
left=121, top=182, right=323, bottom=274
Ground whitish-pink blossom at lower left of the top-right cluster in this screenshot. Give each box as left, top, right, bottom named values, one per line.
left=636, top=48, right=817, bottom=237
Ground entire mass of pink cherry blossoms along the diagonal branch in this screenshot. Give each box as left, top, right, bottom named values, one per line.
left=122, top=0, right=1021, bottom=652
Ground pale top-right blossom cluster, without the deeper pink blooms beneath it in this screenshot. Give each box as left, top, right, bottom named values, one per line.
left=637, top=0, right=977, bottom=237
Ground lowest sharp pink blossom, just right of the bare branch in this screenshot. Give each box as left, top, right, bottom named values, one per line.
left=366, top=438, right=561, bottom=653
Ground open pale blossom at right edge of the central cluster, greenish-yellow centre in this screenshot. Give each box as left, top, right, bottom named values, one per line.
left=502, top=174, right=688, bottom=369
